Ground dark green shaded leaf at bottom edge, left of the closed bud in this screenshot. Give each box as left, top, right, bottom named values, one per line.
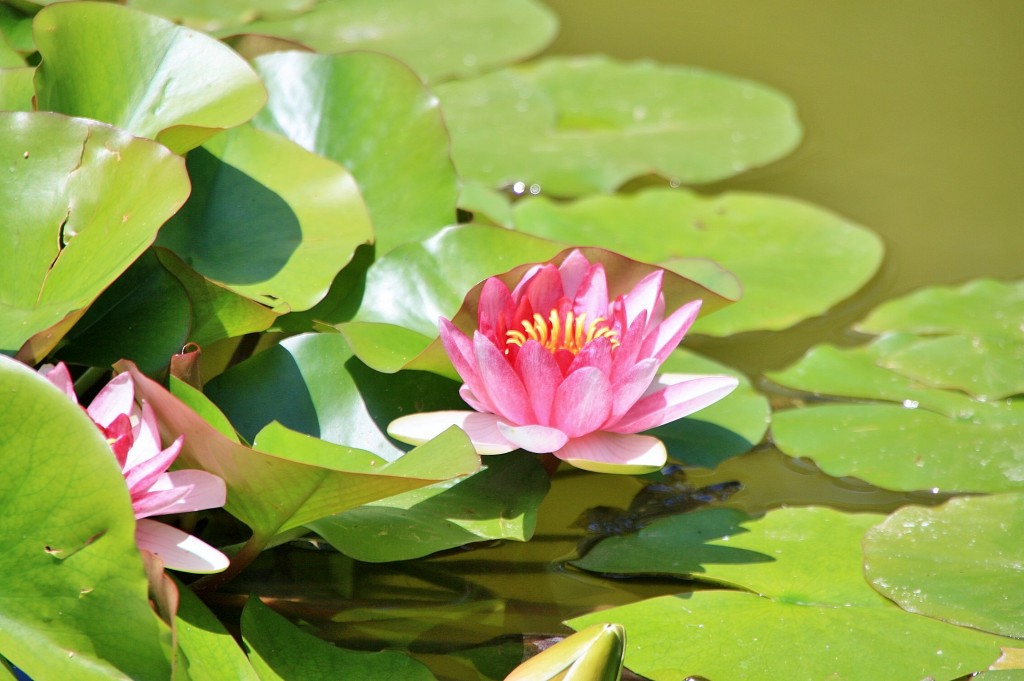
left=242, top=596, right=434, bottom=681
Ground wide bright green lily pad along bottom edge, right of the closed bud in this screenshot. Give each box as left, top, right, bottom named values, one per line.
left=566, top=591, right=1013, bottom=681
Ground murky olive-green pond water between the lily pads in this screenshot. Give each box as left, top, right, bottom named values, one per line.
left=211, top=0, right=1024, bottom=678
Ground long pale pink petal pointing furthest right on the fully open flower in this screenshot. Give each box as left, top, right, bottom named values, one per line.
left=605, top=374, right=739, bottom=433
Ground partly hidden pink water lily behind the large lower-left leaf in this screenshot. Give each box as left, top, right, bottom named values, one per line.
left=39, top=363, right=228, bottom=573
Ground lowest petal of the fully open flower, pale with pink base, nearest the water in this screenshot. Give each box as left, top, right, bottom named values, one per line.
left=555, top=431, right=668, bottom=474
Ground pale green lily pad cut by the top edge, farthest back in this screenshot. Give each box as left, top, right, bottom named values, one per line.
left=220, top=0, right=558, bottom=81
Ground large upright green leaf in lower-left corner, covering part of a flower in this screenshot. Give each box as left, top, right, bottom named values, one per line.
left=0, top=356, right=171, bottom=681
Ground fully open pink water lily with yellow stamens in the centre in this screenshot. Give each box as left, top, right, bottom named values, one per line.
left=388, top=251, right=737, bottom=473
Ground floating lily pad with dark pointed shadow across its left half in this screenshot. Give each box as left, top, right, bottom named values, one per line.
left=572, top=508, right=886, bottom=606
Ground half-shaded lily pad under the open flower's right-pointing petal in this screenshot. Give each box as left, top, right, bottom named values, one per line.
left=650, top=340, right=771, bottom=468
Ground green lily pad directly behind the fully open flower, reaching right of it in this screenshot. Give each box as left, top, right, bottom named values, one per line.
left=514, top=189, right=884, bottom=336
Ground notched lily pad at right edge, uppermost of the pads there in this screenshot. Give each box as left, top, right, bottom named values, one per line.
left=856, top=280, right=1024, bottom=399
